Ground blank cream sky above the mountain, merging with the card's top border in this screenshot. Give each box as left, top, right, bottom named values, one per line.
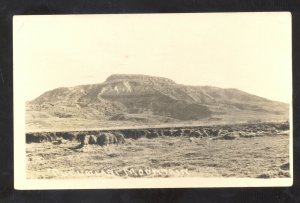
left=13, top=12, right=292, bottom=102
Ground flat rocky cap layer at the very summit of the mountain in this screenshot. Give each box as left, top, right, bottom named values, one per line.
left=105, top=74, right=176, bottom=84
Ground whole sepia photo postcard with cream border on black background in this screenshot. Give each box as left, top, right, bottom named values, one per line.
left=13, top=12, right=293, bottom=189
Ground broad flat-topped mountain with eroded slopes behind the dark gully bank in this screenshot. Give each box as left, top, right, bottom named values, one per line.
left=26, top=74, right=288, bottom=131
